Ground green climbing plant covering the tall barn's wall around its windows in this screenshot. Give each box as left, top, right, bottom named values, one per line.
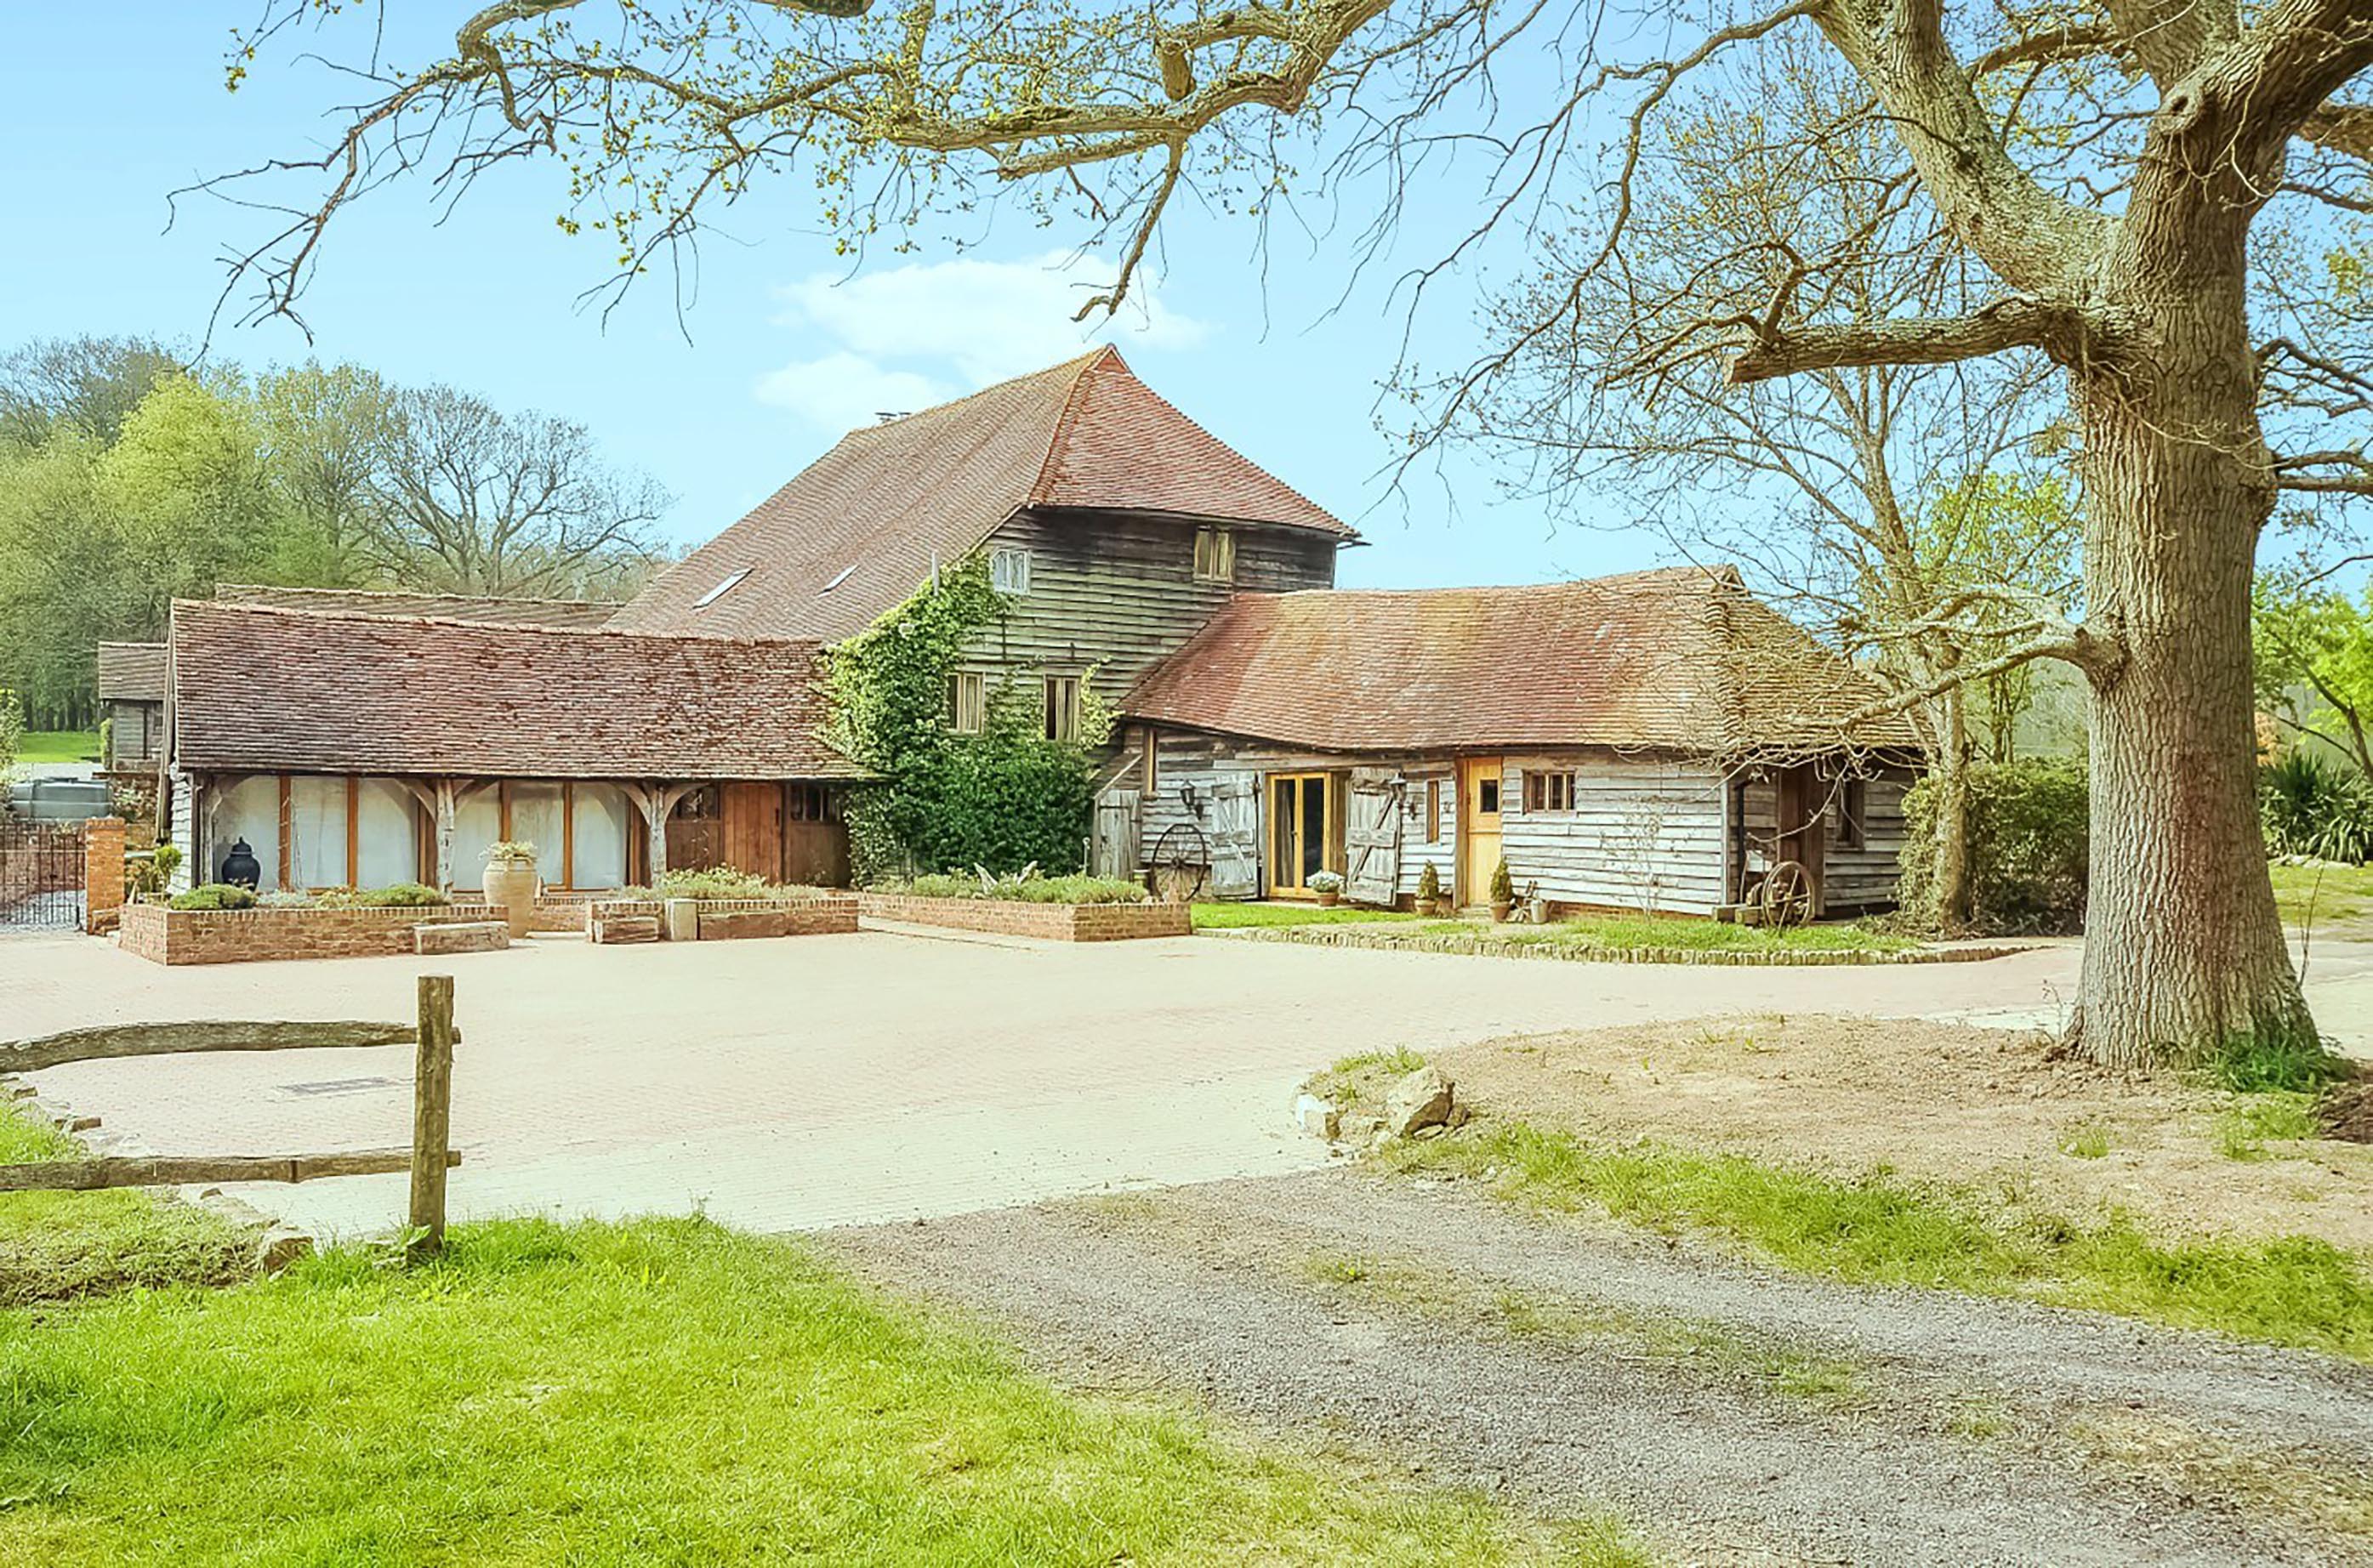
left=828, top=553, right=1113, bottom=883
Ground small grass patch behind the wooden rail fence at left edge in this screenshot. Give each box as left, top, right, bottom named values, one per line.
left=0, top=1105, right=252, bottom=1307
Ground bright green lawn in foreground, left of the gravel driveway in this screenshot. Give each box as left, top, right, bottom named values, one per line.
left=0, top=1219, right=1644, bottom=1568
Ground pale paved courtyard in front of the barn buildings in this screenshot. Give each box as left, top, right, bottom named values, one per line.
left=0, top=915, right=2373, bottom=1234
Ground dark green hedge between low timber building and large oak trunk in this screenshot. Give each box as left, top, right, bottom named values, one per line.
left=1901, top=759, right=2093, bottom=935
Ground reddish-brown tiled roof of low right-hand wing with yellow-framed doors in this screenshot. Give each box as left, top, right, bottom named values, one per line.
left=1123, top=567, right=1915, bottom=754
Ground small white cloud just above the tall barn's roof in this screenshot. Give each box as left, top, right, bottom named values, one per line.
left=757, top=252, right=1210, bottom=432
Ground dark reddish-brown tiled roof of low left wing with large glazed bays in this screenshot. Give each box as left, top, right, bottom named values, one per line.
left=174, top=600, right=862, bottom=781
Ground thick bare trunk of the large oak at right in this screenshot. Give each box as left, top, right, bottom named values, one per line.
left=2074, top=247, right=2313, bottom=1067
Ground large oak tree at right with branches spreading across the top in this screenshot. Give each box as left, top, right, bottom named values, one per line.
left=218, top=0, right=2373, bottom=1063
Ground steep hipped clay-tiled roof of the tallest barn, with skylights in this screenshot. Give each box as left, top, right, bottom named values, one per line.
left=610, top=349, right=1355, bottom=643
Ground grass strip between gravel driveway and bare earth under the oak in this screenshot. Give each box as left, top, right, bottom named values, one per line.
left=1384, top=1122, right=2373, bottom=1361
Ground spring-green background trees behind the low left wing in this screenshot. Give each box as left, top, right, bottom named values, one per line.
left=0, top=337, right=669, bottom=728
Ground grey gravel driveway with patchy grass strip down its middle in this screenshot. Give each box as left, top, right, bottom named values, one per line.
left=831, top=1169, right=2373, bottom=1568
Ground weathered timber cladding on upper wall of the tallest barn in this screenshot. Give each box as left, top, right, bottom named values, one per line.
left=966, top=513, right=1339, bottom=702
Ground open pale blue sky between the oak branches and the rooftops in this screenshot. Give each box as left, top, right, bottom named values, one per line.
left=0, top=0, right=1659, bottom=586
